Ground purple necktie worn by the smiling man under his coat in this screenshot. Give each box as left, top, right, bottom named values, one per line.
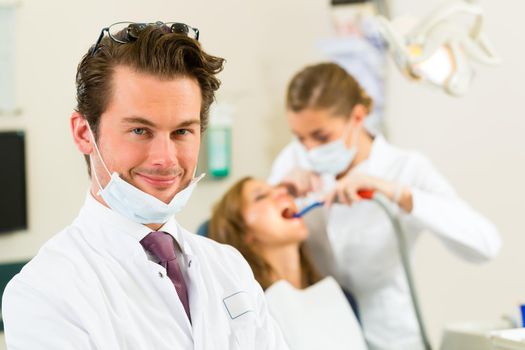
left=140, top=231, right=191, bottom=322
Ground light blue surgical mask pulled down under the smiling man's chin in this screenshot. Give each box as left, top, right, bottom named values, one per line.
left=89, top=129, right=205, bottom=224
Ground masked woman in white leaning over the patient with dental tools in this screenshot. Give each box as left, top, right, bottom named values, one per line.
left=269, top=63, right=500, bottom=350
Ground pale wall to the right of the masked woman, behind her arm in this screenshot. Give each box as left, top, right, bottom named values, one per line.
left=387, top=0, right=525, bottom=340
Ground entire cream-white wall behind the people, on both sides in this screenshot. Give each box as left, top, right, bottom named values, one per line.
left=0, top=0, right=525, bottom=349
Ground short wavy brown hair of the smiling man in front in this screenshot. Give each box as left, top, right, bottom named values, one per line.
left=76, top=25, right=224, bottom=171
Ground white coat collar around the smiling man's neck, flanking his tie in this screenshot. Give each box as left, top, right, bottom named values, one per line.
left=76, top=191, right=193, bottom=257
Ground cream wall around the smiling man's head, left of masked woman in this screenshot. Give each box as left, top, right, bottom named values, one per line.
left=0, top=0, right=328, bottom=261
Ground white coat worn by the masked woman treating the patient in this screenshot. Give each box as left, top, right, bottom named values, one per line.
left=269, top=136, right=500, bottom=350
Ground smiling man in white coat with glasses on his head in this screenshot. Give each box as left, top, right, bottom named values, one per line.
left=3, top=22, right=287, bottom=350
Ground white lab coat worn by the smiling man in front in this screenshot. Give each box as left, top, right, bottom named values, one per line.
left=3, top=194, right=287, bottom=350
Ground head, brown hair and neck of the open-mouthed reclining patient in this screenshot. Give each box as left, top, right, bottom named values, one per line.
left=209, top=177, right=319, bottom=290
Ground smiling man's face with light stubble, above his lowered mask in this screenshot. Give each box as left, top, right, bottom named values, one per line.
left=91, top=66, right=201, bottom=203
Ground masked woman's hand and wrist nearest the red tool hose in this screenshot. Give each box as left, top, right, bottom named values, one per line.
left=325, top=171, right=413, bottom=213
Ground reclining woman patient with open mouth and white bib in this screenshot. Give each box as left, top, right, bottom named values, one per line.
left=209, top=177, right=366, bottom=350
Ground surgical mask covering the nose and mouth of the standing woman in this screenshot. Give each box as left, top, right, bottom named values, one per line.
left=306, top=125, right=357, bottom=176
